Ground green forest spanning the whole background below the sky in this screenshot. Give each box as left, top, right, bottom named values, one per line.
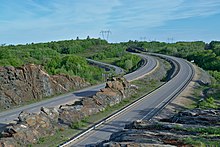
left=0, top=38, right=220, bottom=81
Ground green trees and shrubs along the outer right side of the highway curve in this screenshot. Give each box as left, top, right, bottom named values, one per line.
left=124, top=41, right=220, bottom=108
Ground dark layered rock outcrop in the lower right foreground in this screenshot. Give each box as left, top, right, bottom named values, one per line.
left=96, top=109, right=220, bottom=147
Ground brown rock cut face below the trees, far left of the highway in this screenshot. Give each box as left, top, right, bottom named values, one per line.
left=0, top=64, right=89, bottom=108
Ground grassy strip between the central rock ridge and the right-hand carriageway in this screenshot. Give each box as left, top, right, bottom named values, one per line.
left=32, top=59, right=171, bottom=147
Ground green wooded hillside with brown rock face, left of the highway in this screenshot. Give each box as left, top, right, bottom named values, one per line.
left=0, top=39, right=141, bottom=109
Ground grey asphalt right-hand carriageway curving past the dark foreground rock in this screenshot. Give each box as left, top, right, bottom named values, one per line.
left=66, top=54, right=194, bottom=147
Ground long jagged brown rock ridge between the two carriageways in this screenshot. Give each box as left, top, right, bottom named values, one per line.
left=0, top=78, right=135, bottom=147
